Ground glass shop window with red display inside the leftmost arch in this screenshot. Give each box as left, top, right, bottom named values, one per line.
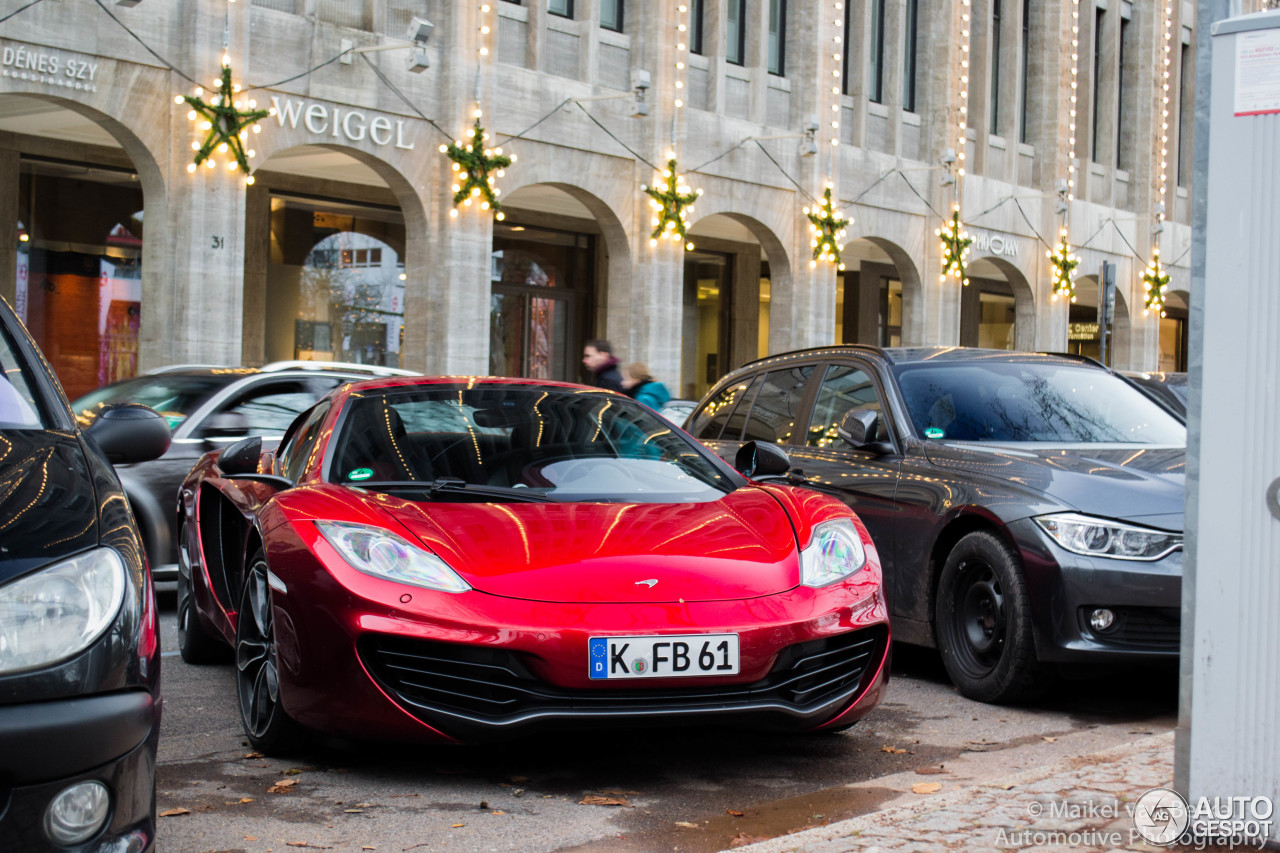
left=14, top=156, right=143, bottom=398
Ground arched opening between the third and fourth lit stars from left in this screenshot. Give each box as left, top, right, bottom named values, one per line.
left=678, top=213, right=790, bottom=400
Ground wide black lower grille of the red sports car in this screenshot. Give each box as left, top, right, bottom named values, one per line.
left=358, top=625, right=887, bottom=726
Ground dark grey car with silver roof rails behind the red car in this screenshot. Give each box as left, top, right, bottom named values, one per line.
left=72, top=361, right=413, bottom=581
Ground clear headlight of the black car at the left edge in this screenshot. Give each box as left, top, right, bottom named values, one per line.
left=0, top=548, right=128, bottom=674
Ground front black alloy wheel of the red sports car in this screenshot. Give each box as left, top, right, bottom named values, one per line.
left=236, top=551, right=302, bottom=754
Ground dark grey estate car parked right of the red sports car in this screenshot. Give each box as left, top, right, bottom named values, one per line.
left=686, top=346, right=1187, bottom=702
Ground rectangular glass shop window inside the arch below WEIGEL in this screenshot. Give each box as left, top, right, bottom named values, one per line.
left=264, top=195, right=404, bottom=368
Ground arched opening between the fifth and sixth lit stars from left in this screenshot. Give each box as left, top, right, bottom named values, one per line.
left=960, top=256, right=1036, bottom=350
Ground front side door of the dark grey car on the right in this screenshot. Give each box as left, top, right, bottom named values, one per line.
left=785, top=361, right=902, bottom=612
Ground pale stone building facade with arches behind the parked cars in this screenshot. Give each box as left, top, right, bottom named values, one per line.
left=0, top=0, right=1218, bottom=397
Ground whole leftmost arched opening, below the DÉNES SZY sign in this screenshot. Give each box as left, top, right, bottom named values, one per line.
left=0, top=93, right=165, bottom=398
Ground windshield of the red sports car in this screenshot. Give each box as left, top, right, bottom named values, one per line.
left=330, top=383, right=741, bottom=503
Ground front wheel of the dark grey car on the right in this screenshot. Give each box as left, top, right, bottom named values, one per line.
left=934, top=532, right=1053, bottom=704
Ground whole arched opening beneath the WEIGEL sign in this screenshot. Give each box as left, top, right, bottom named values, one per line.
left=252, top=145, right=422, bottom=368
